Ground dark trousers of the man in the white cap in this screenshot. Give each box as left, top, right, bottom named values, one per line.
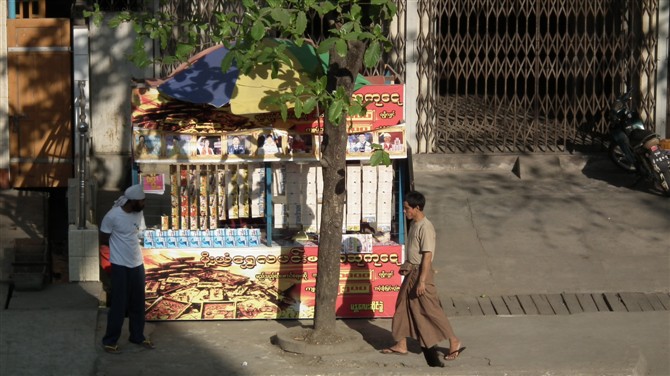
left=102, top=264, right=145, bottom=345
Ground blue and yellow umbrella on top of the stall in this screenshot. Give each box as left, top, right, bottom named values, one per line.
left=158, top=38, right=369, bottom=115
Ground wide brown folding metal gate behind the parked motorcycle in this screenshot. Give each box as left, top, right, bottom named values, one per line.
left=417, top=0, right=658, bottom=153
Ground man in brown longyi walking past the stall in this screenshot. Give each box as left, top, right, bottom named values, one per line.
left=381, top=191, right=465, bottom=367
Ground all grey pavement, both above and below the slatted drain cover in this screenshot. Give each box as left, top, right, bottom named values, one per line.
left=0, top=153, right=670, bottom=376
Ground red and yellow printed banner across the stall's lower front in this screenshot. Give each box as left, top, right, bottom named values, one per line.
left=143, top=244, right=402, bottom=321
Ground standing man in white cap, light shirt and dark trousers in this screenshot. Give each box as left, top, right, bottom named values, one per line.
left=100, top=184, right=154, bottom=354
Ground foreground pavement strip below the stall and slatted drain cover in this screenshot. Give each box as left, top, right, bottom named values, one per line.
left=0, top=283, right=670, bottom=376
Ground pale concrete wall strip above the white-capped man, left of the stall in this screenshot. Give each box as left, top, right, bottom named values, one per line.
left=89, top=14, right=152, bottom=190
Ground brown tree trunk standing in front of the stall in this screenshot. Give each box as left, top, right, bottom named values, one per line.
left=312, top=42, right=365, bottom=334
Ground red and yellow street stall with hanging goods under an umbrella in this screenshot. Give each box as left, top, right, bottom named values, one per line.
left=113, top=39, right=407, bottom=320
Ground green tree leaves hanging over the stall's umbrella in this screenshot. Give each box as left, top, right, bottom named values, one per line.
left=86, top=0, right=397, bottom=132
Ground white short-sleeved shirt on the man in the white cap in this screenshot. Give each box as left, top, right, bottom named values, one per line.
left=100, top=206, right=146, bottom=268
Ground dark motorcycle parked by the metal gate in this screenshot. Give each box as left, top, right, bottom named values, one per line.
left=607, top=89, right=670, bottom=196
